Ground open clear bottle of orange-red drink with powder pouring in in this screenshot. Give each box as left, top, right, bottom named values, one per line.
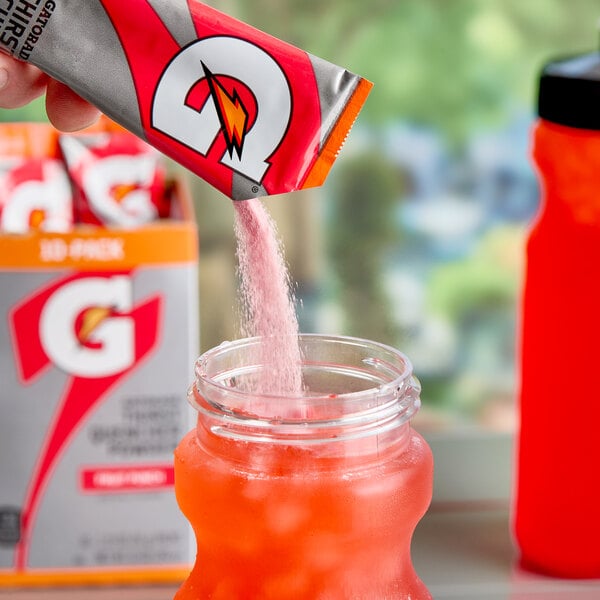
left=175, top=335, right=433, bottom=600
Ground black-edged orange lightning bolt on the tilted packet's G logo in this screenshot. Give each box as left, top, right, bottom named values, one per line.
left=202, top=63, right=248, bottom=159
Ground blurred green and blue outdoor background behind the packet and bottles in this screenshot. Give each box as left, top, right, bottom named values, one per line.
left=0, top=0, right=600, bottom=431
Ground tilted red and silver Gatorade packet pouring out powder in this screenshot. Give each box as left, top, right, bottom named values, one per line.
left=0, top=0, right=371, bottom=200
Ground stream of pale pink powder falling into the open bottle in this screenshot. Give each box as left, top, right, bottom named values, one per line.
left=233, top=199, right=302, bottom=396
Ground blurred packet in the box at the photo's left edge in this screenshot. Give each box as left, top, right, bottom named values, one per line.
left=0, top=123, right=73, bottom=233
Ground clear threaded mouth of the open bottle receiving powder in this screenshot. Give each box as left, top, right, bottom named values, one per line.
left=188, top=334, right=421, bottom=443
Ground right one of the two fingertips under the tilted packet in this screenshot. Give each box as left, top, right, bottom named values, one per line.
left=46, top=79, right=100, bottom=131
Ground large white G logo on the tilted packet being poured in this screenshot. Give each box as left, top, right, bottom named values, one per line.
left=152, top=36, right=292, bottom=183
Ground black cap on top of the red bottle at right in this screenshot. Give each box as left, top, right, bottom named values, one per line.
left=538, top=52, right=600, bottom=130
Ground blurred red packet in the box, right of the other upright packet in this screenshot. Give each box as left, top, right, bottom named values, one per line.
left=59, top=130, right=169, bottom=227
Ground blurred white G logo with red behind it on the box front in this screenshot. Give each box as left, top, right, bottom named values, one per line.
left=10, top=273, right=161, bottom=383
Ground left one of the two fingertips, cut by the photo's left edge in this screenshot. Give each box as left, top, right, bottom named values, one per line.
left=0, top=54, right=48, bottom=108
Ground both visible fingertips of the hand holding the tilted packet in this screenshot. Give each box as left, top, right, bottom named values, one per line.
left=0, top=54, right=100, bottom=131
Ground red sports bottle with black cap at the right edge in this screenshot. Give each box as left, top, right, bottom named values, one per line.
left=514, top=53, right=600, bottom=577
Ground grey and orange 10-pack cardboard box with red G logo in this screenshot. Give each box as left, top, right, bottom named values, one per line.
left=0, top=177, right=198, bottom=588
